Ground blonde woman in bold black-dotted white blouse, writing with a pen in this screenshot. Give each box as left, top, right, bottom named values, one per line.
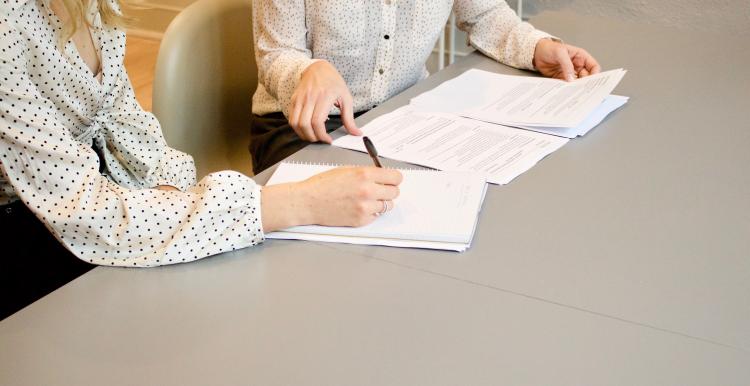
left=0, top=0, right=401, bottom=318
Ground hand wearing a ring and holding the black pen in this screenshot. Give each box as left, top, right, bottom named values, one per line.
left=261, top=167, right=403, bottom=232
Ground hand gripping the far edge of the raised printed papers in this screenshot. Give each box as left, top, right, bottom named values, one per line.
left=534, top=39, right=601, bottom=82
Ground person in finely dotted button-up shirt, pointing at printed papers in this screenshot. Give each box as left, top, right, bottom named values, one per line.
left=250, top=0, right=599, bottom=172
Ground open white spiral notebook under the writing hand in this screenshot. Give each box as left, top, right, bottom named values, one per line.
left=266, top=162, right=487, bottom=252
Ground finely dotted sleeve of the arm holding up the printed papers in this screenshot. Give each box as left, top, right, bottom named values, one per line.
left=453, top=0, right=550, bottom=69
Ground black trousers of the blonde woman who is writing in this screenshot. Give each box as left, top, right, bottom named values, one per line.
left=0, top=201, right=95, bottom=320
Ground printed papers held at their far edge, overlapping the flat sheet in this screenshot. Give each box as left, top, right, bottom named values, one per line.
left=411, top=69, right=628, bottom=138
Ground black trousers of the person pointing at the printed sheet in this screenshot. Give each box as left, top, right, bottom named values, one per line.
left=249, top=111, right=365, bottom=174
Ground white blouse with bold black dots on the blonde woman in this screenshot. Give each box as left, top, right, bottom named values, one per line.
left=0, top=0, right=264, bottom=267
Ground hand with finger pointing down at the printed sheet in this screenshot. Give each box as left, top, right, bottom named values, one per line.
left=289, top=60, right=362, bottom=143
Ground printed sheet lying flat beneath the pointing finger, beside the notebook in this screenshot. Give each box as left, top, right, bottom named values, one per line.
left=333, top=106, right=568, bottom=184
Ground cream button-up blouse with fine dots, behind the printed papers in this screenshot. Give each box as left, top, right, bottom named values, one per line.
left=253, top=0, right=549, bottom=115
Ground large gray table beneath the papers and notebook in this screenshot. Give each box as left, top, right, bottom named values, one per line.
left=0, top=13, right=750, bottom=385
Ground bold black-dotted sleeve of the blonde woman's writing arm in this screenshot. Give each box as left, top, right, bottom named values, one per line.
left=0, top=21, right=264, bottom=267
